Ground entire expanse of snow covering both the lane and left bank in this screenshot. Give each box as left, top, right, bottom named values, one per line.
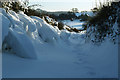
left=0, top=8, right=118, bottom=78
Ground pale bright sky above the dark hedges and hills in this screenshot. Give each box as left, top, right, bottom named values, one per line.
left=29, top=0, right=104, bottom=11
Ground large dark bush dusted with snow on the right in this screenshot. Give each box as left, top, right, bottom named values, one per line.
left=84, top=2, right=120, bottom=43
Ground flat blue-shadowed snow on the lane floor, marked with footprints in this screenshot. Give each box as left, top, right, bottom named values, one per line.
left=3, top=39, right=118, bottom=78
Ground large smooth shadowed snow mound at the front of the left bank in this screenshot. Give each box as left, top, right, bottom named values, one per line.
left=6, top=27, right=37, bottom=59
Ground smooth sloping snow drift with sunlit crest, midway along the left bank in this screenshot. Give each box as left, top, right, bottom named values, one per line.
left=32, top=17, right=60, bottom=43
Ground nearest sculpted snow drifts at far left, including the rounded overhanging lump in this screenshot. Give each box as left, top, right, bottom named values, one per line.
left=0, top=9, right=37, bottom=58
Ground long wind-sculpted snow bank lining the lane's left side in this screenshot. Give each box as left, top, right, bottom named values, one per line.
left=0, top=8, right=84, bottom=58
